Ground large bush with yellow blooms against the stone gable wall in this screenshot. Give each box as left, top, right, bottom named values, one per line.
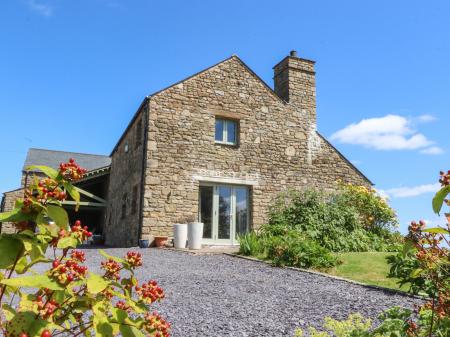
left=263, top=185, right=396, bottom=252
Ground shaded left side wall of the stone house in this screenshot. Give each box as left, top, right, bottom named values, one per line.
left=103, top=101, right=147, bottom=247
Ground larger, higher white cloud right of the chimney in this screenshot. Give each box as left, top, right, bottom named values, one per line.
left=331, top=115, right=434, bottom=150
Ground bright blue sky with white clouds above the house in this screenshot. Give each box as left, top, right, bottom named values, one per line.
left=0, top=0, right=450, bottom=229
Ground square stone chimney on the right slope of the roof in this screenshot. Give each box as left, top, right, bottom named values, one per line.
left=273, top=50, right=316, bottom=127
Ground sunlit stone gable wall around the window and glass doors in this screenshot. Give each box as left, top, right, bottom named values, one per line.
left=141, top=57, right=370, bottom=235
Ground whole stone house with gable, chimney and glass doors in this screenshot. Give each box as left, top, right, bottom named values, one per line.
left=0, top=51, right=371, bottom=246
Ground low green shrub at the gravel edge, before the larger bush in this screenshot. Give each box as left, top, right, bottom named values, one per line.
left=267, top=231, right=338, bottom=269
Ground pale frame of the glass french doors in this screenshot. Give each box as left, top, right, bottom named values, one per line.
left=198, top=182, right=250, bottom=245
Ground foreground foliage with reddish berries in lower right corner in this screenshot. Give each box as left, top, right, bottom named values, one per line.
left=296, top=171, right=450, bottom=337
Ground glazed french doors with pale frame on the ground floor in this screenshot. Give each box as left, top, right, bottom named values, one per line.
left=199, top=184, right=249, bottom=244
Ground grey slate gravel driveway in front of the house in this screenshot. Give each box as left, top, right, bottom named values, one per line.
left=80, top=249, right=418, bottom=337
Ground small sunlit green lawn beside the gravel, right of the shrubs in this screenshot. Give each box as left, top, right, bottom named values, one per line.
left=328, top=252, right=408, bottom=291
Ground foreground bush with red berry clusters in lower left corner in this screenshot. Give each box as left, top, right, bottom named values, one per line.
left=0, top=159, right=170, bottom=337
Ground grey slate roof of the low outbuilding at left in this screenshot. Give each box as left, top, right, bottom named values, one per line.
left=23, top=148, right=111, bottom=171
